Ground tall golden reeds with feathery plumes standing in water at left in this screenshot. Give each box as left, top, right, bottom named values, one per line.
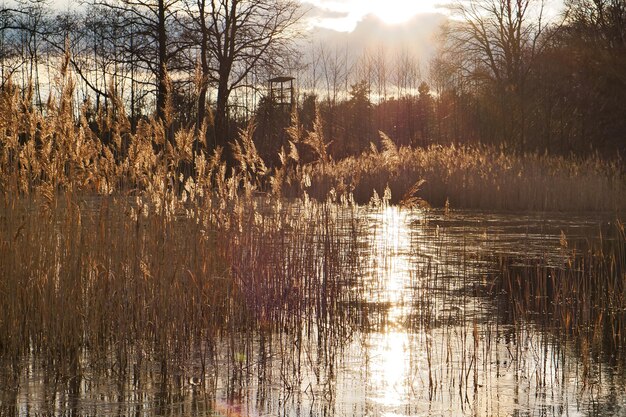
left=0, top=68, right=359, bottom=415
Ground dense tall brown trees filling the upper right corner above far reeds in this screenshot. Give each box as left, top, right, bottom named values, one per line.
left=433, top=0, right=626, bottom=156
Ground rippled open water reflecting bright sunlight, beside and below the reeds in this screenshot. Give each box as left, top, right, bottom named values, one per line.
left=0, top=207, right=626, bottom=416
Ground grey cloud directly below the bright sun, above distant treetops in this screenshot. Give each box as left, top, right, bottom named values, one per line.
left=292, top=4, right=448, bottom=91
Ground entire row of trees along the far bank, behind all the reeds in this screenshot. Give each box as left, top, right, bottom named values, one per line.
left=0, top=0, right=626, bottom=164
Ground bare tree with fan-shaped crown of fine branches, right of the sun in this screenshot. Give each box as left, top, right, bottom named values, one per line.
left=438, top=0, right=548, bottom=149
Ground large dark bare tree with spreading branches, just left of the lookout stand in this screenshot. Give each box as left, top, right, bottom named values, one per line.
left=189, top=0, right=302, bottom=152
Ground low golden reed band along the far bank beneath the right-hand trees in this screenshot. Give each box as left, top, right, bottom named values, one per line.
left=311, top=135, right=626, bottom=211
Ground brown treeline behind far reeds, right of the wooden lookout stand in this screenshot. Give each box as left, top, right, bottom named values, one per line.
left=280, top=0, right=626, bottom=158
